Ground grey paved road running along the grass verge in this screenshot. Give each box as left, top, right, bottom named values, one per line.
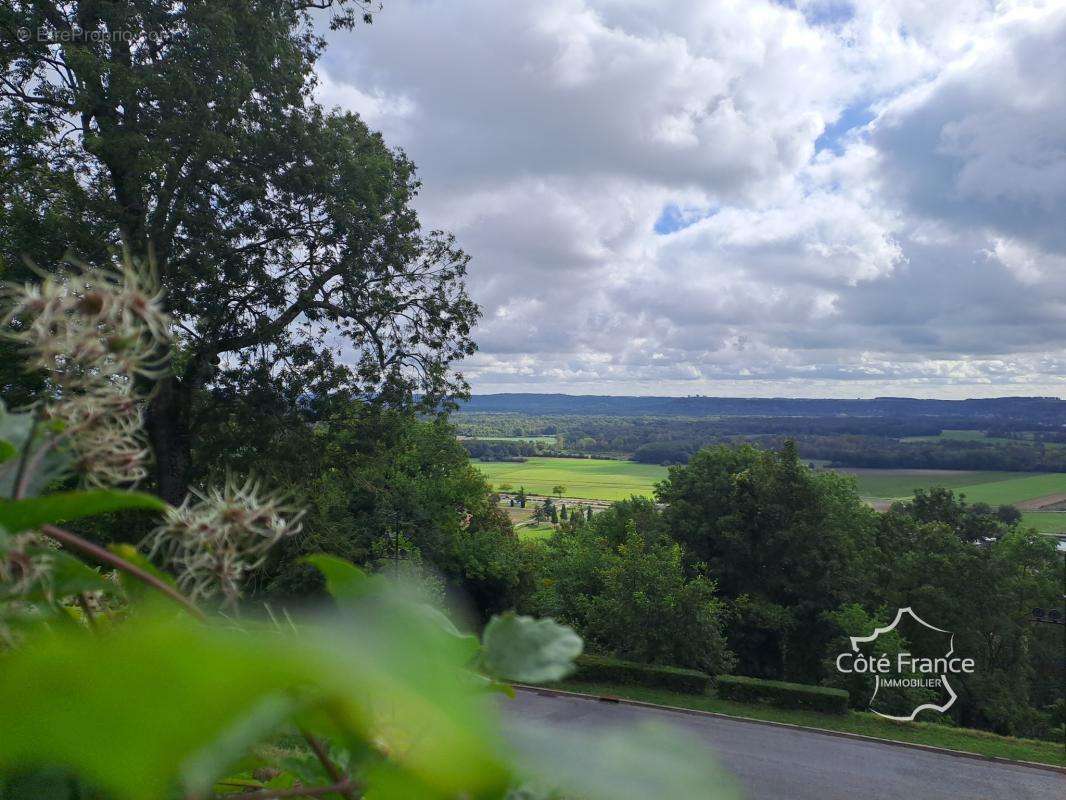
left=504, top=691, right=1066, bottom=800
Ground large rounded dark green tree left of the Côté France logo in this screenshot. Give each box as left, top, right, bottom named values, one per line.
left=658, top=443, right=876, bottom=681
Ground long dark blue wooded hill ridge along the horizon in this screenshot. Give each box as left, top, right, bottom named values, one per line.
left=461, top=394, right=1066, bottom=427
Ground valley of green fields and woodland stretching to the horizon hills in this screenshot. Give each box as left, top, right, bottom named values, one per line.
left=456, top=395, right=1066, bottom=535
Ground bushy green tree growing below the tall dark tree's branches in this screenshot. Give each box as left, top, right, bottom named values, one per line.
left=194, top=384, right=531, bottom=620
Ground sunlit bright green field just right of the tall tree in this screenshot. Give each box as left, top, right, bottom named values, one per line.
left=471, top=458, right=666, bottom=500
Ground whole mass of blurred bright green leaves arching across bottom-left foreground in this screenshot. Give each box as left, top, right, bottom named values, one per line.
left=0, top=584, right=510, bottom=800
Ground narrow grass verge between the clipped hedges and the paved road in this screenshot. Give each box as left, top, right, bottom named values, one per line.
left=559, top=682, right=1066, bottom=766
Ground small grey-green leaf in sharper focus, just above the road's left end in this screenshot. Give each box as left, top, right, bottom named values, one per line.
left=481, top=611, right=583, bottom=683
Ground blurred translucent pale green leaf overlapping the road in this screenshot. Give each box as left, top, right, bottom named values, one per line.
left=508, top=723, right=743, bottom=800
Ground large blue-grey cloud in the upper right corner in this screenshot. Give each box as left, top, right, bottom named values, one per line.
left=871, top=3, right=1066, bottom=251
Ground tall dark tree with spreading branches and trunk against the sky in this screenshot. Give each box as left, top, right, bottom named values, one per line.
left=0, top=0, right=479, bottom=501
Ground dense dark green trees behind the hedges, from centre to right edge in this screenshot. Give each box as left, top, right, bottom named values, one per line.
left=644, top=447, right=1064, bottom=736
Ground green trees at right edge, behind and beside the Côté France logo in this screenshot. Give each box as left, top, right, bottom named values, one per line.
left=862, top=507, right=1064, bottom=735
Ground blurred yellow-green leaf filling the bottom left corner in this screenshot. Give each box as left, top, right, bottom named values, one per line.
left=0, top=623, right=309, bottom=800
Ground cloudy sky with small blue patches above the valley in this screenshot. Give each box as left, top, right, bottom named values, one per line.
left=317, top=0, right=1066, bottom=398
